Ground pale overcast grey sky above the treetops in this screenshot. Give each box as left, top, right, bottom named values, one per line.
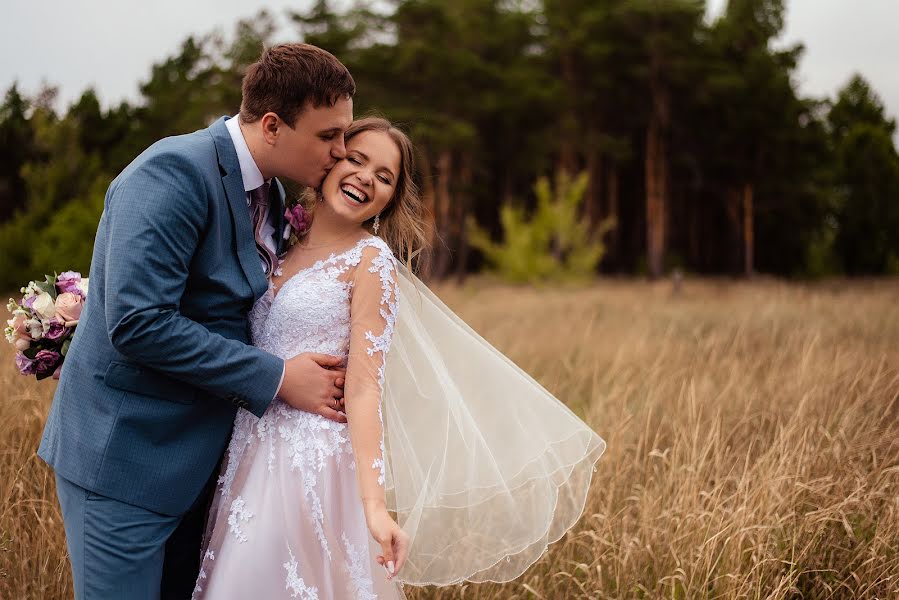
left=0, top=0, right=899, bottom=127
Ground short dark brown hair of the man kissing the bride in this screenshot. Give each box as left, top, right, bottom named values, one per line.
left=240, top=44, right=356, bottom=127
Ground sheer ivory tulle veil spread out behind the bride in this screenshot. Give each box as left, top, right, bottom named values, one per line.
left=383, top=266, right=606, bottom=585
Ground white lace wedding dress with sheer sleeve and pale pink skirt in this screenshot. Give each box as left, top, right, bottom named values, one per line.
left=193, top=237, right=405, bottom=600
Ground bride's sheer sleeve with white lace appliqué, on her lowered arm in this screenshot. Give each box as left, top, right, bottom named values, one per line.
left=344, top=245, right=399, bottom=506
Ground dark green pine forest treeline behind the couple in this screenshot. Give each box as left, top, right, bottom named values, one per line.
left=0, top=0, right=899, bottom=289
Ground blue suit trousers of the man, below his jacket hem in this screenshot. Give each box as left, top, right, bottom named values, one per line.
left=56, top=471, right=218, bottom=600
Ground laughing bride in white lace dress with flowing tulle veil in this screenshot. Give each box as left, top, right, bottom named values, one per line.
left=193, top=118, right=605, bottom=600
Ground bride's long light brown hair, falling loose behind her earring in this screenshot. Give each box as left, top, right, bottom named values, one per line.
left=303, top=117, right=427, bottom=270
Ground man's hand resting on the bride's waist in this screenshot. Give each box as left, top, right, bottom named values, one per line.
left=278, top=352, right=347, bottom=423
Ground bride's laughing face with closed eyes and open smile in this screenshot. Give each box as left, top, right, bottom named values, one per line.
left=322, top=131, right=400, bottom=224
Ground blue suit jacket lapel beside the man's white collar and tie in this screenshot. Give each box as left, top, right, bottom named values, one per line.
left=209, top=117, right=268, bottom=300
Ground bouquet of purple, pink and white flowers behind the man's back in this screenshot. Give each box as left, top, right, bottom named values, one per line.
left=6, top=271, right=88, bottom=379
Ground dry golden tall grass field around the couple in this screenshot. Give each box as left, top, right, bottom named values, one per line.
left=0, top=280, right=899, bottom=600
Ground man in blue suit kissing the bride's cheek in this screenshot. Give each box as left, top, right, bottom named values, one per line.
left=38, top=44, right=355, bottom=600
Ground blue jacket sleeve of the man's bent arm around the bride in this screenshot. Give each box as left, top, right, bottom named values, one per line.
left=104, top=153, right=284, bottom=416
